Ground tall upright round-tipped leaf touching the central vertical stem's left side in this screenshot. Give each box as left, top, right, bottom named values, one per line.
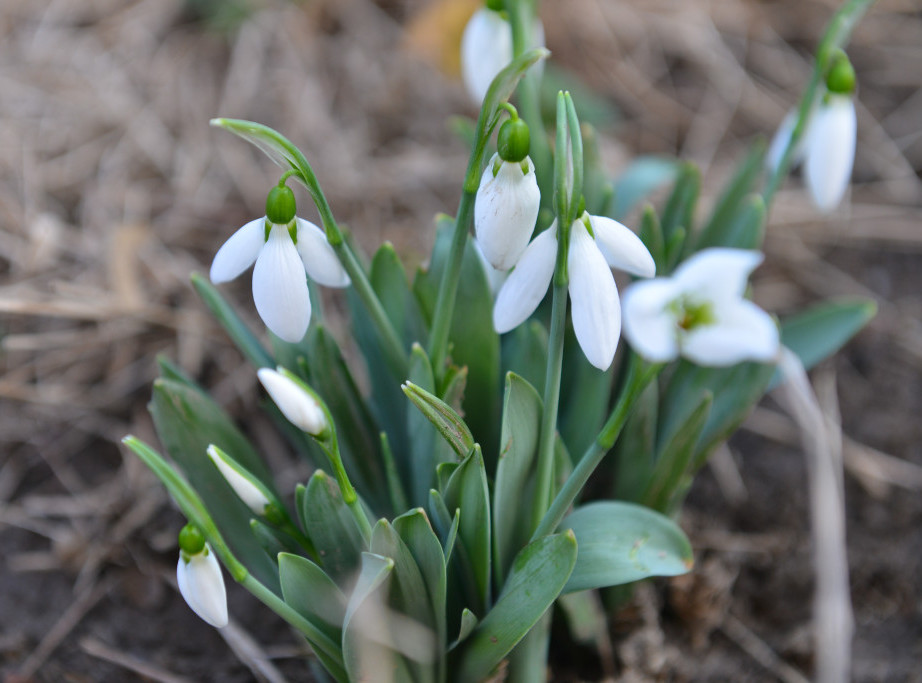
left=493, top=372, right=542, bottom=581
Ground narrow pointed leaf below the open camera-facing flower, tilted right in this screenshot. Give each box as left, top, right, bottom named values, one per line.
left=644, top=391, right=713, bottom=512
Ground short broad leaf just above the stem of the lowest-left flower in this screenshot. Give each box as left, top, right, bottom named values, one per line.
left=278, top=553, right=347, bottom=648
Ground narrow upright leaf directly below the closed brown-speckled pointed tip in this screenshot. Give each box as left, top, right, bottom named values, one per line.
left=444, top=446, right=491, bottom=609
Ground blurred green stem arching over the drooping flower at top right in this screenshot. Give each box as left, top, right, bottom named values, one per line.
left=762, top=0, right=875, bottom=207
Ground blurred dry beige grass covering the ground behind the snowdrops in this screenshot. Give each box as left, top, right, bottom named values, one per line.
left=0, top=0, right=922, bottom=680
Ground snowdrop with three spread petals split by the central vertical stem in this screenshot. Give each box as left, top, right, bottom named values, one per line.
left=493, top=213, right=656, bottom=370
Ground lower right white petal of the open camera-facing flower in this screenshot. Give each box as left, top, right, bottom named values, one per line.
left=682, top=299, right=780, bottom=367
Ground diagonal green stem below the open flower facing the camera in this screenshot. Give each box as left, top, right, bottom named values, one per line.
left=531, top=356, right=663, bottom=541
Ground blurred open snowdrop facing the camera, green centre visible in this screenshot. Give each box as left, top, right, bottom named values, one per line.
left=622, top=247, right=779, bottom=366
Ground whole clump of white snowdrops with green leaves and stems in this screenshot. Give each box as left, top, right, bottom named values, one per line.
left=125, top=0, right=873, bottom=681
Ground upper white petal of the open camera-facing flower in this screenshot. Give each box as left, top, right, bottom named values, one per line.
left=673, top=247, right=762, bottom=301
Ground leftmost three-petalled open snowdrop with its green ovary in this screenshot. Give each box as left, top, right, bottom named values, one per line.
left=211, top=184, right=349, bottom=343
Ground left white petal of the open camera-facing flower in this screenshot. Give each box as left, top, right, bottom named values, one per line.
left=621, top=278, right=680, bottom=363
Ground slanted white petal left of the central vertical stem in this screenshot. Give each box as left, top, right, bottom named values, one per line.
left=493, top=224, right=557, bottom=334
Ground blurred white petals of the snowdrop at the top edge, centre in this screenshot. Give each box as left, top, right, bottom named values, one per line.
left=461, top=7, right=544, bottom=103
